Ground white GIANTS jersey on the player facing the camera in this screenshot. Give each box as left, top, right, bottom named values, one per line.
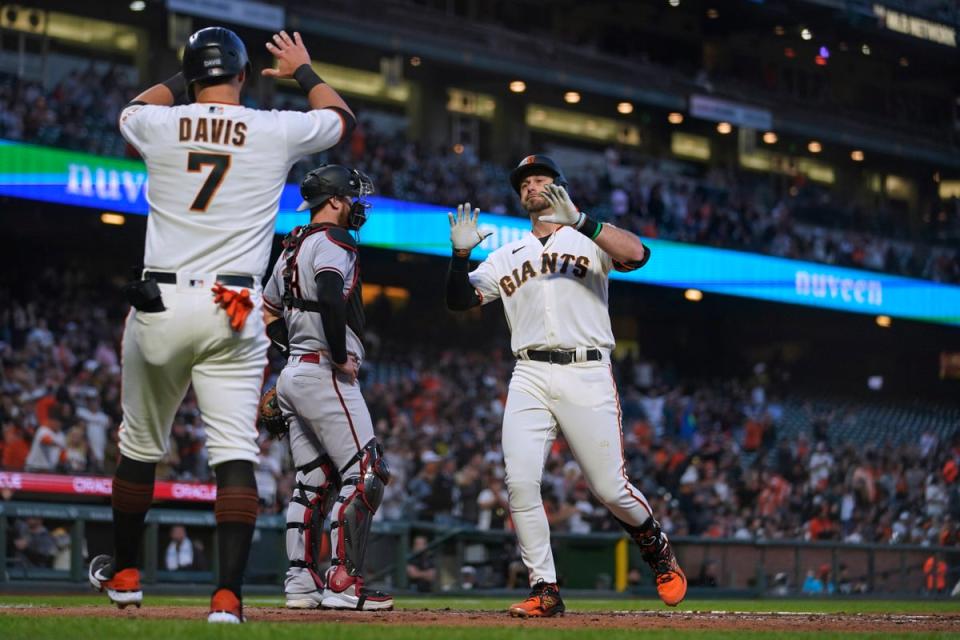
left=470, top=227, right=640, bottom=353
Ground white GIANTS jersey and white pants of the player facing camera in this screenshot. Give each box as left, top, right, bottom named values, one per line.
left=469, top=227, right=651, bottom=585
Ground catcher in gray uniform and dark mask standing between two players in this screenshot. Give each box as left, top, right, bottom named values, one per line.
left=261, top=165, right=393, bottom=611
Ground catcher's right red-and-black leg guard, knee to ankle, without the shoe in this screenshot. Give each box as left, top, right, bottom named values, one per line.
left=330, top=439, right=390, bottom=576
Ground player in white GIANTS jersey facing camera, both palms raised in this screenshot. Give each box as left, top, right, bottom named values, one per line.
left=447, top=155, right=687, bottom=617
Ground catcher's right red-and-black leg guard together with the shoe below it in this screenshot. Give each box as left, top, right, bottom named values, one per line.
left=323, top=440, right=393, bottom=610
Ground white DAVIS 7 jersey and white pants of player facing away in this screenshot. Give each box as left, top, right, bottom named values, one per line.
left=120, top=102, right=344, bottom=465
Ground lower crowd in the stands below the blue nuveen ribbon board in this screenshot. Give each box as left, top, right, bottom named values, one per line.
left=0, top=269, right=960, bottom=545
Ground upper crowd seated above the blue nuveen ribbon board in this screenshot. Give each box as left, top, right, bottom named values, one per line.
left=0, top=65, right=960, bottom=283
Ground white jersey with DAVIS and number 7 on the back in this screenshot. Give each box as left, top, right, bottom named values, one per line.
left=120, top=102, right=344, bottom=277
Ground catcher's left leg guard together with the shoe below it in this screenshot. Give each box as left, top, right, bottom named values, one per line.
left=284, top=454, right=340, bottom=609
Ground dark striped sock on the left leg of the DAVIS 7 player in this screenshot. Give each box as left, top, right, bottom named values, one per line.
left=110, top=456, right=157, bottom=571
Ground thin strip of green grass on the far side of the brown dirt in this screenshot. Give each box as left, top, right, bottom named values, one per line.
left=0, top=593, right=960, bottom=615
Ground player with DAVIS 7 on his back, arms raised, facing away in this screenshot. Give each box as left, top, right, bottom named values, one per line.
left=89, top=27, right=355, bottom=622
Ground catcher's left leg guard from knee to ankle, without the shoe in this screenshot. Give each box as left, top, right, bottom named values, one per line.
left=287, top=454, right=340, bottom=575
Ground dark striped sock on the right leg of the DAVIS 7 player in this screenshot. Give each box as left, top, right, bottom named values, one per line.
left=214, top=460, right=258, bottom=598
